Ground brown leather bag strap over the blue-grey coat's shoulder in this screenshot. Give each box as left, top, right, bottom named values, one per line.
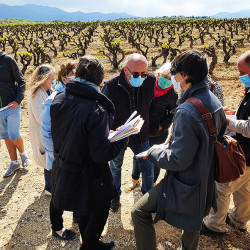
left=185, top=97, right=218, bottom=138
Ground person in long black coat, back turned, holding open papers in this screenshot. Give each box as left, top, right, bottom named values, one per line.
left=50, top=56, right=128, bottom=250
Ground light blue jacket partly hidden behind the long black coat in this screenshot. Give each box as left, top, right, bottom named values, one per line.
left=41, top=82, right=65, bottom=170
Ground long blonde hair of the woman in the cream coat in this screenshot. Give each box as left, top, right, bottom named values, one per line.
left=29, top=64, right=56, bottom=98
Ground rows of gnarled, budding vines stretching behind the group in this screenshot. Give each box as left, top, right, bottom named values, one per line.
left=0, top=18, right=250, bottom=74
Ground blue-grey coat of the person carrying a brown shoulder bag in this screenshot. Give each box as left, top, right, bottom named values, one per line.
left=148, top=81, right=227, bottom=231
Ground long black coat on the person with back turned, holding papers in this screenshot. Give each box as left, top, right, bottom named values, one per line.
left=50, top=80, right=127, bottom=215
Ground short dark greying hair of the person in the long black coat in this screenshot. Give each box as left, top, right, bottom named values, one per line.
left=76, top=55, right=105, bottom=86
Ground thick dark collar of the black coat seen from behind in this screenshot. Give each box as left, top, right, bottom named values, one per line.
left=66, top=80, right=115, bottom=115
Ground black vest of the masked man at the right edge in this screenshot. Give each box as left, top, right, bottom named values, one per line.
left=236, top=89, right=250, bottom=166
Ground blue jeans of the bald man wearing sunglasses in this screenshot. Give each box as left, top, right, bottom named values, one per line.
left=110, top=140, right=154, bottom=196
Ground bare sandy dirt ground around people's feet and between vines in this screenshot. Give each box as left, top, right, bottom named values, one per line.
left=0, top=24, right=250, bottom=250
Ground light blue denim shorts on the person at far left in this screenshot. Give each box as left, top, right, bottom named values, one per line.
left=0, top=105, right=21, bottom=141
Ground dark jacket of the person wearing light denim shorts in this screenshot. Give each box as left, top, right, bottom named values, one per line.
left=0, top=51, right=25, bottom=108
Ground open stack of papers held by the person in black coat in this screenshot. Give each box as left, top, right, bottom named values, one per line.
left=108, top=111, right=144, bottom=142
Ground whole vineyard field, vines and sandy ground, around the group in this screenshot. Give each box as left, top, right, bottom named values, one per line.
left=0, top=19, right=250, bottom=250
